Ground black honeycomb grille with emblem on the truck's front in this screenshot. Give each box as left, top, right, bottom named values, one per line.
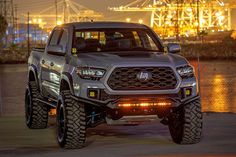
left=107, top=67, right=177, bottom=90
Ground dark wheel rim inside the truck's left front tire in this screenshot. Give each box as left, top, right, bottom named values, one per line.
left=57, top=105, right=65, bottom=142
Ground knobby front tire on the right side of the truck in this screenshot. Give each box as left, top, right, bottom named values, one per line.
left=169, top=99, right=202, bottom=144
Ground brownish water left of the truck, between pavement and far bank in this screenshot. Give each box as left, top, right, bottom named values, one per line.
left=0, top=64, right=27, bottom=116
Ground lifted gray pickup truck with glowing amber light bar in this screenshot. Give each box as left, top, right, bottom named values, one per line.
left=25, top=22, right=202, bottom=149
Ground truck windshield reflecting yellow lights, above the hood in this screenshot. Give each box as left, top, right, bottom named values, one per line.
left=73, top=28, right=160, bottom=53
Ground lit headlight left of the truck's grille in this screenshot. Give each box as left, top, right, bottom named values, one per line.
left=77, top=67, right=106, bottom=80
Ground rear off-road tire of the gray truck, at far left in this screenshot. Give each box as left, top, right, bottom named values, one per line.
left=25, top=81, right=48, bottom=129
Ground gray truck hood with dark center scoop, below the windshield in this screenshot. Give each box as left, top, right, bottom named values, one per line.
left=78, top=52, right=188, bottom=68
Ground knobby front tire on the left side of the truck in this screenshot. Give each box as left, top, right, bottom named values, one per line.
left=57, top=90, right=86, bottom=149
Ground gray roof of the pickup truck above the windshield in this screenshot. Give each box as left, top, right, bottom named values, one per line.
left=63, top=22, right=148, bottom=29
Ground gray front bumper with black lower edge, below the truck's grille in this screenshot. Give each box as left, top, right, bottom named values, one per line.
left=74, top=77, right=198, bottom=109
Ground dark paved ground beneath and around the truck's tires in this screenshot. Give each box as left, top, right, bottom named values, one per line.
left=0, top=113, right=236, bottom=157
